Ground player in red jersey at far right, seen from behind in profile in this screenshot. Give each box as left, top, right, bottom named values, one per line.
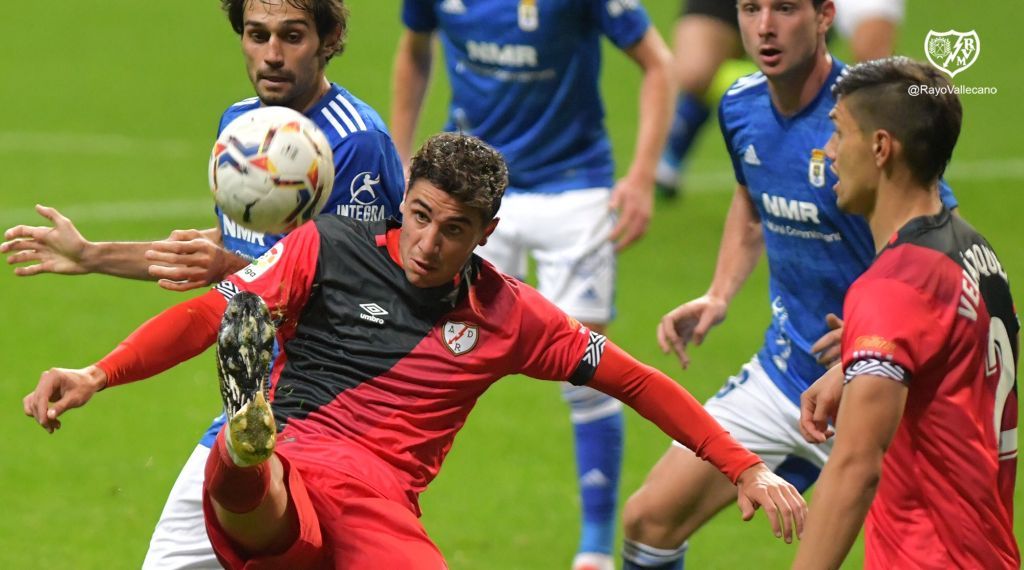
left=795, top=57, right=1020, bottom=569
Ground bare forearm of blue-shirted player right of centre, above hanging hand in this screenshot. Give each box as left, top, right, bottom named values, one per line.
left=708, top=184, right=764, bottom=305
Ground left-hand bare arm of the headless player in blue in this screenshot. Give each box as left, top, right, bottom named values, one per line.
left=391, top=30, right=433, bottom=169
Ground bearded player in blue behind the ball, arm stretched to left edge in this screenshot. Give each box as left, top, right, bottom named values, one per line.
left=0, top=0, right=404, bottom=569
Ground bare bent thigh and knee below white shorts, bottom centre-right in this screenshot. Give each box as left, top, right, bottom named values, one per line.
left=623, top=444, right=736, bottom=549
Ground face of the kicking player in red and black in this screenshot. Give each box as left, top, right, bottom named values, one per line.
left=398, top=179, right=498, bottom=288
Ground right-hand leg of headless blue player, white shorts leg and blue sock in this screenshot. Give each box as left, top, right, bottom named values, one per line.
left=528, top=188, right=624, bottom=570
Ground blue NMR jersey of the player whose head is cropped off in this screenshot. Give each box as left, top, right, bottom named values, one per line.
left=402, top=0, right=650, bottom=192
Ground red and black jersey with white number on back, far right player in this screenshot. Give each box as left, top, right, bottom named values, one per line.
left=843, top=209, right=1020, bottom=569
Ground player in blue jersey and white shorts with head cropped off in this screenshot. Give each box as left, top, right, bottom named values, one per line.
left=391, top=0, right=672, bottom=568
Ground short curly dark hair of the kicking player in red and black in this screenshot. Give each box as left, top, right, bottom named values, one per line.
left=409, top=133, right=509, bottom=223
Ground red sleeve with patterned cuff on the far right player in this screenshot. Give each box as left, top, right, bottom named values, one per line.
left=843, top=277, right=943, bottom=383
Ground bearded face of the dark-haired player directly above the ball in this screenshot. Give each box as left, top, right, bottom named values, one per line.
left=242, top=0, right=327, bottom=113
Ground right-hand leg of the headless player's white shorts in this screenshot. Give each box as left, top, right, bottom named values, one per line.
left=519, top=188, right=615, bottom=324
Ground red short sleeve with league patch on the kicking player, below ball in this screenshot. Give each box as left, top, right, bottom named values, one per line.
left=215, top=222, right=319, bottom=331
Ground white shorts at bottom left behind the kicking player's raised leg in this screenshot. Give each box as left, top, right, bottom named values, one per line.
left=142, top=445, right=221, bottom=570
